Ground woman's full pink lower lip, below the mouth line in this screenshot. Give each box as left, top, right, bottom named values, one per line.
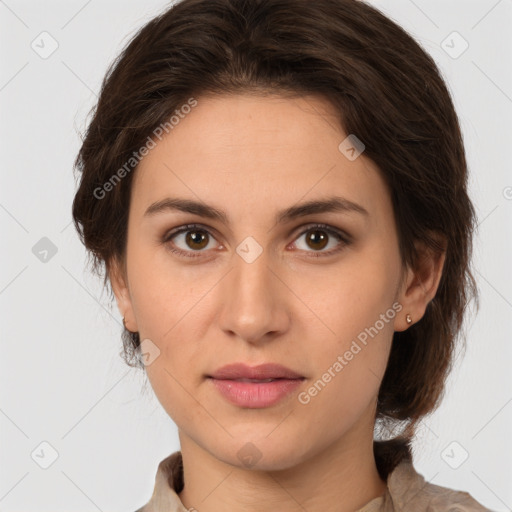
left=210, top=377, right=303, bottom=409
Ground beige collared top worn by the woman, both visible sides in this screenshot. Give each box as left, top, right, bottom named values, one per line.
left=136, top=451, right=492, bottom=512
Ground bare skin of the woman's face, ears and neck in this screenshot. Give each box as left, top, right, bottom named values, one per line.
left=110, top=94, right=444, bottom=512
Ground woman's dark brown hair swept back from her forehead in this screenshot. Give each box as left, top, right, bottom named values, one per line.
left=72, top=0, right=478, bottom=478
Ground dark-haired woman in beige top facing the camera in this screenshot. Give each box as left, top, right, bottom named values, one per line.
left=73, top=0, right=488, bottom=512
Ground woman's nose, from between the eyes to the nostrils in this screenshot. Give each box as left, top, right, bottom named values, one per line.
left=219, top=247, right=290, bottom=344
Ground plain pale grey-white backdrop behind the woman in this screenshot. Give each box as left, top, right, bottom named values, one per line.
left=0, top=0, right=512, bottom=512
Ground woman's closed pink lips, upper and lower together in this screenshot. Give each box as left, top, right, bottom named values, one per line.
left=208, top=363, right=304, bottom=408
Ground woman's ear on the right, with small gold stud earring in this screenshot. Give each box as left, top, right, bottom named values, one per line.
left=395, top=235, right=446, bottom=331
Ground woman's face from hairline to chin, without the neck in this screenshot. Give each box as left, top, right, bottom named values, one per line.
left=113, top=95, right=420, bottom=469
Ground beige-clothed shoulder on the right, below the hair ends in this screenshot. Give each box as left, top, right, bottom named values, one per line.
left=388, top=461, right=492, bottom=512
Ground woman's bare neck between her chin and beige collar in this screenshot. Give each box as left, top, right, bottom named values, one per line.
left=179, top=414, right=386, bottom=512
